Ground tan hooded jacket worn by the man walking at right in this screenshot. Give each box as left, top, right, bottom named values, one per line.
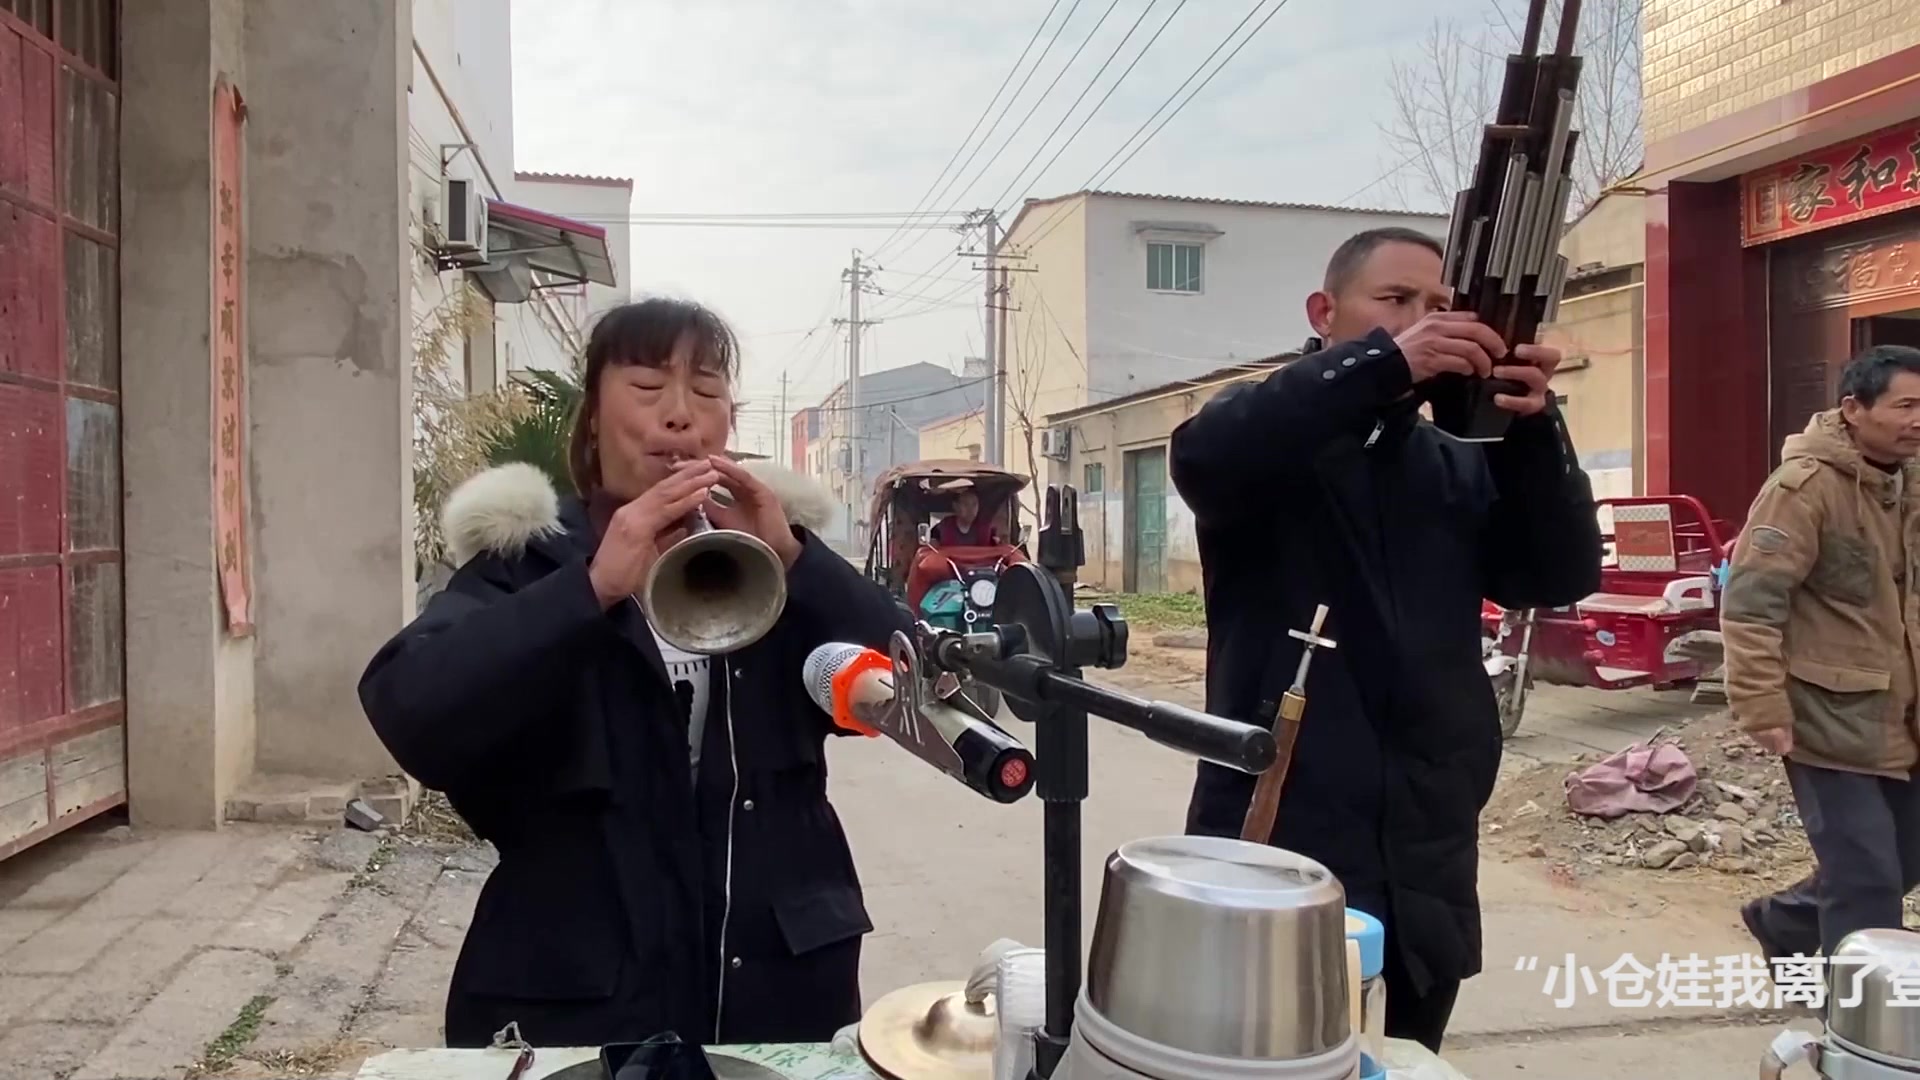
left=1720, top=409, right=1920, bottom=776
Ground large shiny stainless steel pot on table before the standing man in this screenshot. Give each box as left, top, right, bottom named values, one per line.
left=1087, top=836, right=1350, bottom=1061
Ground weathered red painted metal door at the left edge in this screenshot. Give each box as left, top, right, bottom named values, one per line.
left=0, top=0, right=127, bottom=857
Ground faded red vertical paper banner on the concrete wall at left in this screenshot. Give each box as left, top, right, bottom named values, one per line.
left=211, top=81, right=253, bottom=638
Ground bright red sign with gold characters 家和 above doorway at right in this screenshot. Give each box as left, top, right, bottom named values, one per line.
left=1740, top=121, right=1920, bottom=246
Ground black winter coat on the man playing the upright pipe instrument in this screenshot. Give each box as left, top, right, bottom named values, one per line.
left=1171, top=331, right=1601, bottom=994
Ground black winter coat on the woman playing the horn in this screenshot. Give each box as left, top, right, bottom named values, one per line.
left=361, top=467, right=906, bottom=1045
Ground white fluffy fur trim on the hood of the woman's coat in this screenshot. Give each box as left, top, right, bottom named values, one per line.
left=440, top=461, right=833, bottom=567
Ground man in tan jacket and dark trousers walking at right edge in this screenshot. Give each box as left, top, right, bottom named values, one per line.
left=1720, top=346, right=1920, bottom=957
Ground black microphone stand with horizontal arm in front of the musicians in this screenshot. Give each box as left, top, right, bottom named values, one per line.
left=910, top=563, right=1277, bottom=1080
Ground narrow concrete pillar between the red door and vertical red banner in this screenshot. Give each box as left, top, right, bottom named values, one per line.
left=121, top=0, right=255, bottom=828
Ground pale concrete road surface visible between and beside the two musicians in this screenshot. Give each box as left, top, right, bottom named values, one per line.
left=833, top=671, right=1812, bottom=1080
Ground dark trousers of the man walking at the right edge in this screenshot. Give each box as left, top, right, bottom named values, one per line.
left=1745, top=761, right=1920, bottom=955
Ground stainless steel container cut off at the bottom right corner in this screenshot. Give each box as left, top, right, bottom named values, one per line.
left=1826, top=930, right=1920, bottom=1070
